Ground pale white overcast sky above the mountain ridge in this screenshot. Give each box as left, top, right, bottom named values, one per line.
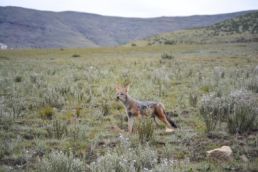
left=0, top=0, right=258, bottom=17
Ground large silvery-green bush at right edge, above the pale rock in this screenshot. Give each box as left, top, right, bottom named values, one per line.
left=199, top=90, right=258, bottom=134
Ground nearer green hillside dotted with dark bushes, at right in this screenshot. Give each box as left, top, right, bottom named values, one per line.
left=131, top=11, right=258, bottom=46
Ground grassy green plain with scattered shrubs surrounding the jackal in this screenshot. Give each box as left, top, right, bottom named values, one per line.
left=0, top=43, right=258, bottom=171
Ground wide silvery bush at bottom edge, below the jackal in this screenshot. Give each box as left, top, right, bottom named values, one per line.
left=90, top=145, right=158, bottom=172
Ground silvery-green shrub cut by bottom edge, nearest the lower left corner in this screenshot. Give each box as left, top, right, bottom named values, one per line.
left=39, top=151, right=86, bottom=172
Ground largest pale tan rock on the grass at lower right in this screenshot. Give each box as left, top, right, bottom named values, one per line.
left=207, top=146, right=232, bottom=161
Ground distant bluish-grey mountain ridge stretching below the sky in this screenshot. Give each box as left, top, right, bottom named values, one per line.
left=0, top=7, right=255, bottom=48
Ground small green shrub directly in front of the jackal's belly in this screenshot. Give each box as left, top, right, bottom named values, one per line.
left=137, top=117, right=154, bottom=144
